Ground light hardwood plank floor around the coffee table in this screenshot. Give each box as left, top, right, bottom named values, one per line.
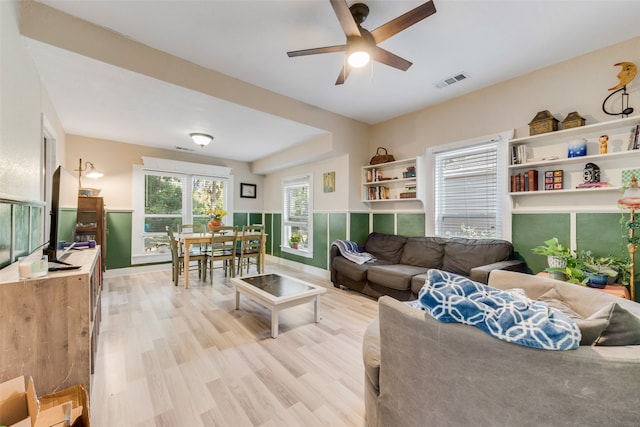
left=91, top=264, right=378, bottom=427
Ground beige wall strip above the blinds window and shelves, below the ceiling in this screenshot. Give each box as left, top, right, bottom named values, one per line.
left=369, top=37, right=640, bottom=159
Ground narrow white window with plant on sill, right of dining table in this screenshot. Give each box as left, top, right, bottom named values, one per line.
left=282, top=175, right=313, bottom=258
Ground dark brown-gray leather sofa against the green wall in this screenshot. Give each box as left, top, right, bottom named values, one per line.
left=330, top=232, right=526, bottom=300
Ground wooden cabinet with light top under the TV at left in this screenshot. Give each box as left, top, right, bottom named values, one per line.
left=0, top=247, right=102, bottom=395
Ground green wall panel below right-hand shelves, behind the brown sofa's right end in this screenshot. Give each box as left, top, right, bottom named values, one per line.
left=511, top=213, right=571, bottom=273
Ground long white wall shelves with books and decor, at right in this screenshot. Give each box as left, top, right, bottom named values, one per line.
left=507, top=116, right=640, bottom=210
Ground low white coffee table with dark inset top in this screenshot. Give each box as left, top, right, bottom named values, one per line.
left=231, top=274, right=327, bottom=338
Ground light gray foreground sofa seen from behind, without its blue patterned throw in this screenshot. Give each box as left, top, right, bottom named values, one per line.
left=363, top=270, right=640, bottom=427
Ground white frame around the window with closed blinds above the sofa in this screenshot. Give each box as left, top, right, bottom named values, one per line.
left=425, top=130, right=513, bottom=239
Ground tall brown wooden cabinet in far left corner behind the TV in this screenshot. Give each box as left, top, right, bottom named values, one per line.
left=75, top=196, right=107, bottom=271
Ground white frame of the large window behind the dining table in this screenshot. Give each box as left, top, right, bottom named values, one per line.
left=131, top=157, right=234, bottom=265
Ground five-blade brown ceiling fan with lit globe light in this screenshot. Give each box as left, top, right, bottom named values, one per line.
left=287, top=0, right=436, bottom=85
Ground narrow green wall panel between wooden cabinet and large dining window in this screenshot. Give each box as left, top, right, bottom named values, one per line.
left=106, top=211, right=133, bottom=270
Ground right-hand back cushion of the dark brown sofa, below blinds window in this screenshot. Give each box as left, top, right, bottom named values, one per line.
left=442, top=237, right=513, bottom=276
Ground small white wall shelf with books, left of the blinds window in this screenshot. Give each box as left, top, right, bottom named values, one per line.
left=361, top=156, right=424, bottom=203
